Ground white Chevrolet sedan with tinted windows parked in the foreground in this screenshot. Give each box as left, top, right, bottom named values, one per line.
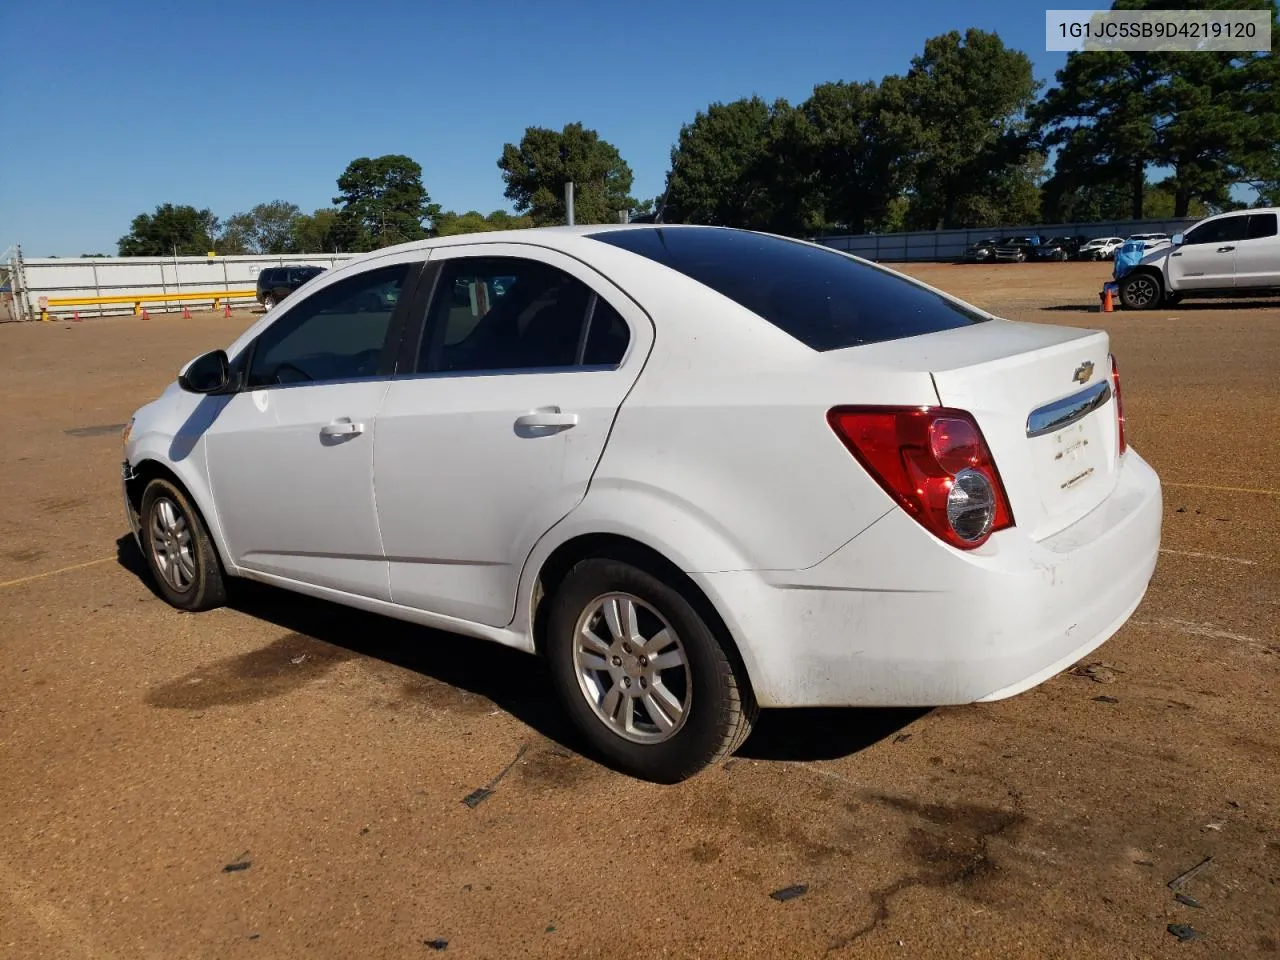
left=124, top=224, right=1161, bottom=782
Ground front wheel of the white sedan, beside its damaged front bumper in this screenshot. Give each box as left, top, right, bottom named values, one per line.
left=141, top=477, right=227, bottom=612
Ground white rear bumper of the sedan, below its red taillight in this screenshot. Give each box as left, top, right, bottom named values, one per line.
left=698, top=451, right=1162, bottom=707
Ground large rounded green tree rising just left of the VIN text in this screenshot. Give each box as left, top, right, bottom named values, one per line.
left=881, top=29, right=1039, bottom=228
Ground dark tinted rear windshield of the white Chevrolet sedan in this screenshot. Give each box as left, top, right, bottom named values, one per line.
left=589, top=227, right=987, bottom=351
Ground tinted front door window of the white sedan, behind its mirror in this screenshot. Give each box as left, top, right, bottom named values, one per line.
left=247, top=264, right=410, bottom=388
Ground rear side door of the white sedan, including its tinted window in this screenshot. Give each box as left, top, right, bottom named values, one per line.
left=374, top=243, right=653, bottom=626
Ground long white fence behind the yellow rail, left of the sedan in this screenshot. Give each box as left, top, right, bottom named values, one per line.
left=10, top=253, right=357, bottom=320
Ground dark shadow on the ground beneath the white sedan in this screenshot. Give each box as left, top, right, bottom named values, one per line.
left=115, top=534, right=928, bottom=763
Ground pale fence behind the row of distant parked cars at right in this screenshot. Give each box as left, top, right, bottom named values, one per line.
left=814, top=216, right=1197, bottom=262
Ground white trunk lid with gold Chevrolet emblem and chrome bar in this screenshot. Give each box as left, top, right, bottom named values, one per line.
left=859, top=319, right=1119, bottom=540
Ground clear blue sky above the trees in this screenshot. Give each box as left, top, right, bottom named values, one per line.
left=0, top=0, right=1065, bottom=256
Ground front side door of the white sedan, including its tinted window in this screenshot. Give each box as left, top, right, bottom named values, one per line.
left=205, top=259, right=425, bottom=599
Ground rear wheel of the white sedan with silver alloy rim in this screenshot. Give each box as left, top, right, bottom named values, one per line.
left=547, top=558, right=756, bottom=783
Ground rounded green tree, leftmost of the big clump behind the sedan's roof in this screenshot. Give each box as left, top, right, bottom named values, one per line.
left=663, top=96, right=800, bottom=229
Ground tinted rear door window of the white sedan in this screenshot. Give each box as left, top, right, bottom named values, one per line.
left=417, top=257, right=630, bottom=372
